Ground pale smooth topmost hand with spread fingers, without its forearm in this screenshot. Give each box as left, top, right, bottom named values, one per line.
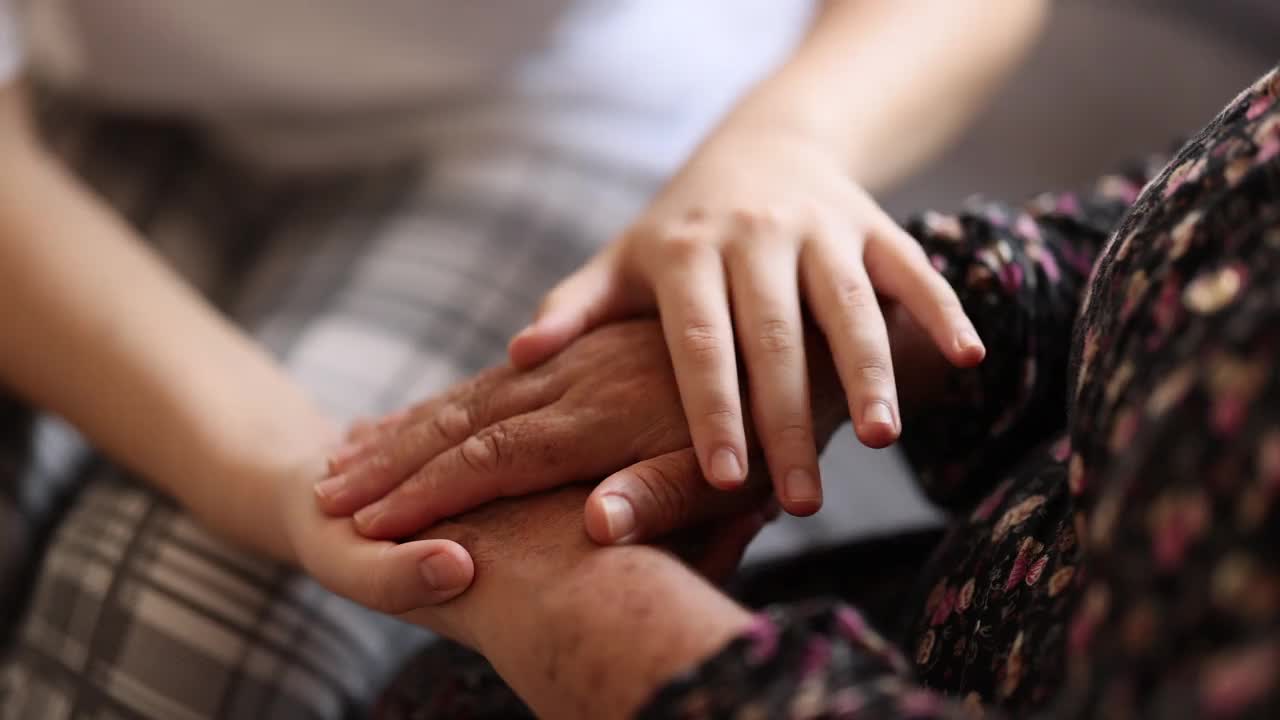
left=509, top=126, right=984, bottom=515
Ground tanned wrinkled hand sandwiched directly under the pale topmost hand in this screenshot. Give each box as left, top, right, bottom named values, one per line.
left=316, top=322, right=844, bottom=543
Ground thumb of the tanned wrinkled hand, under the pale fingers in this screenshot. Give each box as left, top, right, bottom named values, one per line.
left=584, top=447, right=769, bottom=544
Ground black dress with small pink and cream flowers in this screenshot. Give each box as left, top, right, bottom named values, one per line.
left=373, top=64, right=1280, bottom=720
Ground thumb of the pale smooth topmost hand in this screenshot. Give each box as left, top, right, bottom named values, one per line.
left=507, top=251, right=626, bottom=369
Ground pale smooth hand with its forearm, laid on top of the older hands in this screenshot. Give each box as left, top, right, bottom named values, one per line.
left=509, top=0, right=1044, bottom=515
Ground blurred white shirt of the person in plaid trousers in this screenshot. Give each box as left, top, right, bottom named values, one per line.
left=0, top=0, right=814, bottom=172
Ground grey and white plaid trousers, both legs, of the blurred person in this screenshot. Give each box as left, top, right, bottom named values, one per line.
left=0, top=99, right=653, bottom=719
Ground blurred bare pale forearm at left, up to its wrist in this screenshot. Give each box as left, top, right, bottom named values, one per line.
left=0, top=85, right=323, bottom=556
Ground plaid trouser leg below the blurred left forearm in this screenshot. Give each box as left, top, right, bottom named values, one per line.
left=0, top=476, right=410, bottom=717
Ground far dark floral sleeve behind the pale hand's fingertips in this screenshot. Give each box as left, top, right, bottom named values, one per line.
left=901, top=163, right=1162, bottom=511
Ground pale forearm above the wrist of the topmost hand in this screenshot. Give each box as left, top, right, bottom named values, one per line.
left=722, top=0, right=1047, bottom=190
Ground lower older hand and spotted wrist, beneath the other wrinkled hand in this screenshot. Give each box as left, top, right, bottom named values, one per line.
left=404, top=487, right=750, bottom=719
